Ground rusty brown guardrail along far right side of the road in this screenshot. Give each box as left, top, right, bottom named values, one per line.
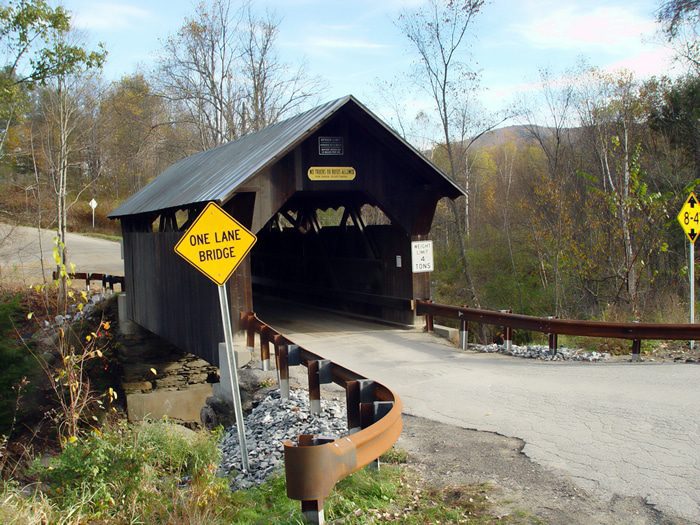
left=416, top=301, right=700, bottom=358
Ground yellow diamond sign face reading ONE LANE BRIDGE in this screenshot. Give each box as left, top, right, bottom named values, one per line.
left=175, top=202, right=258, bottom=286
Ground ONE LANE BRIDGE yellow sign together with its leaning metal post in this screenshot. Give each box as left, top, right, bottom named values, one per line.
left=175, top=202, right=257, bottom=471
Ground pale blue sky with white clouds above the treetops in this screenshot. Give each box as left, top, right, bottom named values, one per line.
left=57, top=0, right=673, bottom=130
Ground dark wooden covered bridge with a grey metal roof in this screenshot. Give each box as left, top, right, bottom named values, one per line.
left=109, top=96, right=463, bottom=365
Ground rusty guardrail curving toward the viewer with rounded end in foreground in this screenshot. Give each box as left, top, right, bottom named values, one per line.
left=241, top=313, right=402, bottom=523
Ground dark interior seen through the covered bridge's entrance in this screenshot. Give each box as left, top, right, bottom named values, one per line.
left=251, top=192, right=413, bottom=323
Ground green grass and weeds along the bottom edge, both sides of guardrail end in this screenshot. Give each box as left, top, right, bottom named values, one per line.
left=0, top=421, right=531, bottom=525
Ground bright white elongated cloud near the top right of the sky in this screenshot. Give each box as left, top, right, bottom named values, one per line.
left=511, top=6, right=656, bottom=52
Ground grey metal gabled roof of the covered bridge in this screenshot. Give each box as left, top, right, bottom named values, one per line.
left=108, top=95, right=464, bottom=218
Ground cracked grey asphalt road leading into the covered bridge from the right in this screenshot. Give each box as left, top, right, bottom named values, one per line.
left=256, top=305, right=700, bottom=523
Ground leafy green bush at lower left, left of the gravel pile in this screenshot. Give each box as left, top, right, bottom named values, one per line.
left=34, top=422, right=226, bottom=522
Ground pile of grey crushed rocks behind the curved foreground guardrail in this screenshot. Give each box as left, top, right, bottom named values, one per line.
left=221, top=389, right=348, bottom=490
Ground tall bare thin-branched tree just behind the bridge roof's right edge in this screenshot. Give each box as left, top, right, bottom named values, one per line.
left=398, top=0, right=484, bottom=307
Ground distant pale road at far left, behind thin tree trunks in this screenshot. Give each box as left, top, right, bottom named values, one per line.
left=0, top=224, right=124, bottom=285
